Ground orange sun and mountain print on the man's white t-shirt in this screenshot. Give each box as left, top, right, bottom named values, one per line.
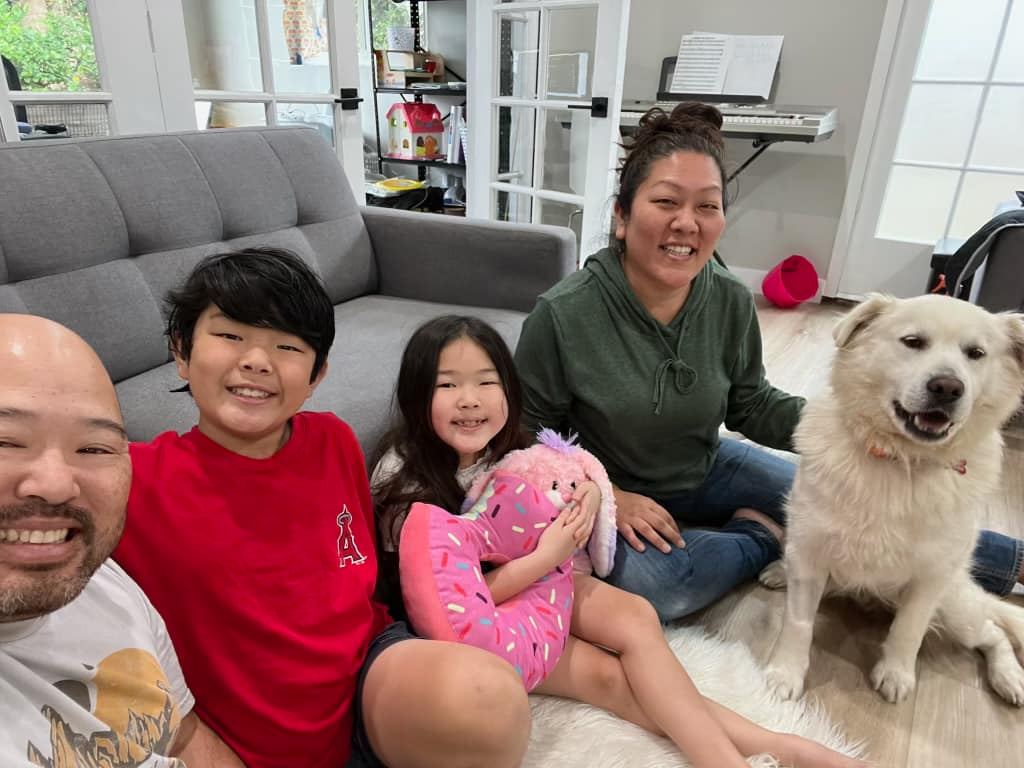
left=27, top=648, right=182, bottom=768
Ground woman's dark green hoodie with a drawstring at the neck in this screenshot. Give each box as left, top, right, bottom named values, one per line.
left=516, top=249, right=804, bottom=497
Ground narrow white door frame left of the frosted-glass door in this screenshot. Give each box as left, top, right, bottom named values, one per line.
left=823, top=0, right=909, bottom=299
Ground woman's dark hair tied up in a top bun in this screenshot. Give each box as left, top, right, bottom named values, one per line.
left=615, top=101, right=728, bottom=224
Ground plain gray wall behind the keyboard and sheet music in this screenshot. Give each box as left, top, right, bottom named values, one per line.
left=624, top=0, right=886, bottom=280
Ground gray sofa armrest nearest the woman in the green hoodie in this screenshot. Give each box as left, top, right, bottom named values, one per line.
left=360, top=206, right=577, bottom=312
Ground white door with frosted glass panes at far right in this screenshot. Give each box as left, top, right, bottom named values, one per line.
left=825, top=0, right=1024, bottom=298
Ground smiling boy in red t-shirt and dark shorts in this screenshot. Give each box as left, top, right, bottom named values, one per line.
left=115, top=249, right=529, bottom=768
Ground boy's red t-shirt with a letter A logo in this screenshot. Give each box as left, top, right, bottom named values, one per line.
left=114, top=413, right=387, bottom=768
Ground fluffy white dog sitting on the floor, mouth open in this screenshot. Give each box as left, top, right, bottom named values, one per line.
left=762, top=296, right=1024, bottom=707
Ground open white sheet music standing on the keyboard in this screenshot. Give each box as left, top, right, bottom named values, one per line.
left=672, top=32, right=784, bottom=99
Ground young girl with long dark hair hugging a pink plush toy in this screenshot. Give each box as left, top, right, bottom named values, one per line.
left=372, top=315, right=865, bottom=768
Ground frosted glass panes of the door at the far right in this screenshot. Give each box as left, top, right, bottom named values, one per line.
left=876, top=0, right=1024, bottom=244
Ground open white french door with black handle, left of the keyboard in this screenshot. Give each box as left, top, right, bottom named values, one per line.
left=467, top=0, right=629, bottom=259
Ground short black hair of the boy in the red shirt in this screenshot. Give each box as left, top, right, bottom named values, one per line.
left=165, top=248, right=334, bottom=383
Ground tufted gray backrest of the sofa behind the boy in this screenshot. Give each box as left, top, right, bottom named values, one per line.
left=0, top=127, right=378, bottom=382
